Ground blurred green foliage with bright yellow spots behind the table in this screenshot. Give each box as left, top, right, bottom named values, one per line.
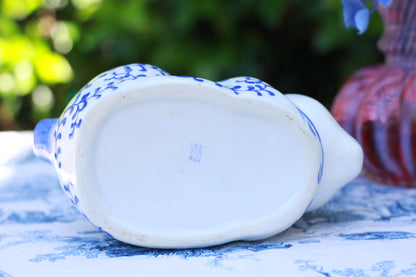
left=0, top=0, right=383, bottom=130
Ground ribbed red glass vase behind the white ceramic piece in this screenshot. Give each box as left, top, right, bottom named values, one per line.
left=332, top=0, right=416, bottom=187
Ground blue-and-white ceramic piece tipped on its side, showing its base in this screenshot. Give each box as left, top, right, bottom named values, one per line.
left=34, top=64, right=363, bottom=248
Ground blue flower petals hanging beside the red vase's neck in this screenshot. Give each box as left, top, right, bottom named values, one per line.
left=341, top=0, right=393, bottom=35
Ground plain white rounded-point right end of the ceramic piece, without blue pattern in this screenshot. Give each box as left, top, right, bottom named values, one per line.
left=285, top=94, right=364, bottom=211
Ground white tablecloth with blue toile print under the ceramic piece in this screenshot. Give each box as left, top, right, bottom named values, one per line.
left=0, top=132, right=416, bottom=276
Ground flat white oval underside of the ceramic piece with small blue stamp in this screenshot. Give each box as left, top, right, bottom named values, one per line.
left=78, top=80, right=319, bottom=248
